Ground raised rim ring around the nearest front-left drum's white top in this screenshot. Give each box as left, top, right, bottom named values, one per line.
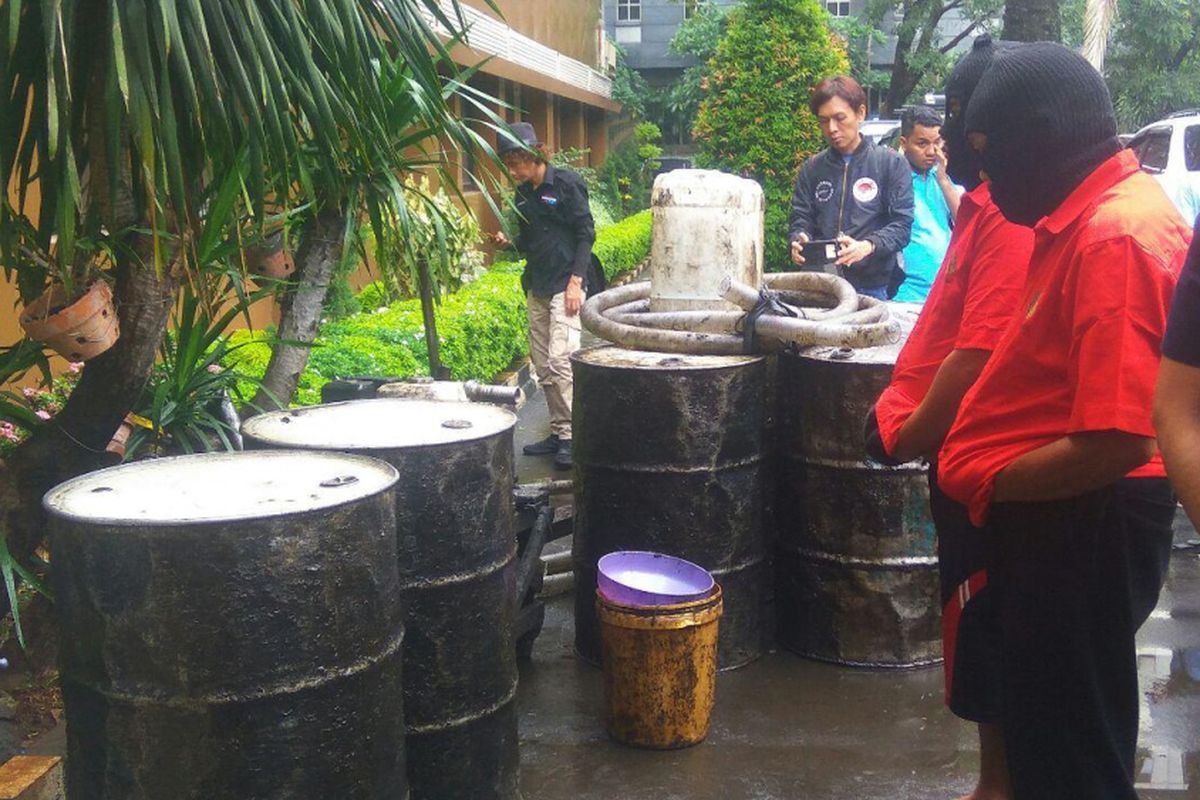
left=42, top=449, right=400, bottom=530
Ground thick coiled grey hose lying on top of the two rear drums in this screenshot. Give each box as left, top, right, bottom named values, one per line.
left=582, top=272, right=900, bottom=355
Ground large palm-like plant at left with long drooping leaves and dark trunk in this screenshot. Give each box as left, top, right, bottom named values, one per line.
left=0, top=0, right=504, bottom=557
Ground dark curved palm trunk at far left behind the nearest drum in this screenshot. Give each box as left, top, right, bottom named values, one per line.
left=0, top=244, right=179, bottom=560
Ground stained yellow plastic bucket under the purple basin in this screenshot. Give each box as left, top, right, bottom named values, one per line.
left=596, top=587, right=722, bottom=750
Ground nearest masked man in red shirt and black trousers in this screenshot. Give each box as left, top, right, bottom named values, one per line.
left=938, top=43, right=1190, bottom=800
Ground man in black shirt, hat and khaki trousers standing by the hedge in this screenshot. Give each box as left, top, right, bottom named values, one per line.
left=496, top=122, right=596, bottom=469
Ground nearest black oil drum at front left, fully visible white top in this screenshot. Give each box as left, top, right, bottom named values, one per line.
left=44, top=452, right=408, bottom=800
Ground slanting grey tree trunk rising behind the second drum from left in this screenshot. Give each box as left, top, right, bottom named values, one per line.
left=247, top=207, right=346, bottom=414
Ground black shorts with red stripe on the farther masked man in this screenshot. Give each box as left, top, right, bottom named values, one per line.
left=929, top=464, right=1001, bottom=722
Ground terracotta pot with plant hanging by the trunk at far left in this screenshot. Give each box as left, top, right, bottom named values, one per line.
left=20, top=281, right=121, bottom=361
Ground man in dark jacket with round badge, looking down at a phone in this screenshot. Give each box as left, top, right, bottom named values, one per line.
left=788, top=76, right=912, bottom=300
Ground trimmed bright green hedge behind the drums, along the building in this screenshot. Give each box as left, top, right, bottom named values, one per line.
left=227, top=211, right=650, bottom=405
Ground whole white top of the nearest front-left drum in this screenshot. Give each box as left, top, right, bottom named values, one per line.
left=43, top=450, right=400, bottom=525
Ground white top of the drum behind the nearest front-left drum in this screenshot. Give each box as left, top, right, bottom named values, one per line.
left=241, top=397, right=517, bottom=450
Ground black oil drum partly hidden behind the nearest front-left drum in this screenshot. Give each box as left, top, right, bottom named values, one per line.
left=242, top=399, right=520, bottom=800
